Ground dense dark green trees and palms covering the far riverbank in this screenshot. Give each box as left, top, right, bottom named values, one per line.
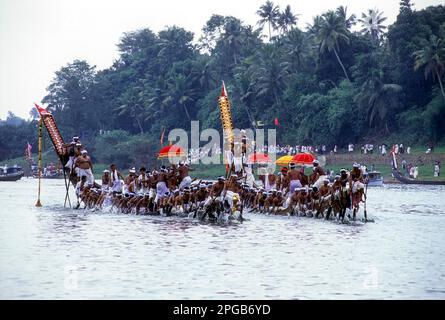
left=0, top=0, right=445, bottom=165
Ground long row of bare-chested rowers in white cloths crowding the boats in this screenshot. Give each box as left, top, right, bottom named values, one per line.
left=75, top=153, right=367, bottom=221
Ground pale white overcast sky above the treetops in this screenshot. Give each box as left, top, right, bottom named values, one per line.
left=0, top=0, right=442, bottom=119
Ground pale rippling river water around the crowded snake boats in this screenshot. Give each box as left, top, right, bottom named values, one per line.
left=0, top=178, right=445, bottom=299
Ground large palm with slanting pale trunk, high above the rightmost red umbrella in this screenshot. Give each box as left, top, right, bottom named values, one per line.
left=318, top=10, right=350, bottom=81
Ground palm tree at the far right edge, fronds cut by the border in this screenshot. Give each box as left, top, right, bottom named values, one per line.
left=413, top=35, right=445, bottom=100
